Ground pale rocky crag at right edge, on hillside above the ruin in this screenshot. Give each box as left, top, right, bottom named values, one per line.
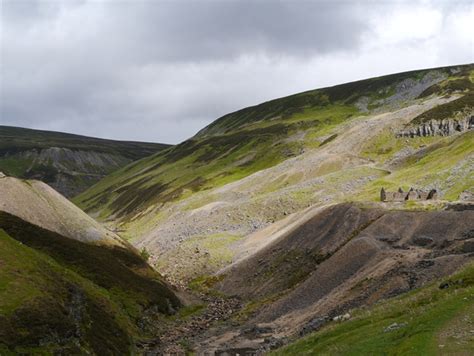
left=397, top=110, right=474, bottom=137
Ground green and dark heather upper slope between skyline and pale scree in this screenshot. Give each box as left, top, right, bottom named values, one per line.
left=75, top=65, right=472, bottom=222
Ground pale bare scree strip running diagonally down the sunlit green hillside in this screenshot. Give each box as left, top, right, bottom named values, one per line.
left=132, top=97, right=462, bottom=282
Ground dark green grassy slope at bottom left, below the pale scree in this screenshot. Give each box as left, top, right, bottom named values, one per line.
left=0, top=212, right=180, bottom=355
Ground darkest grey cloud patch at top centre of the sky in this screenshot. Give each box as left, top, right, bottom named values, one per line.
left=127, top=1, right=366, bottom=61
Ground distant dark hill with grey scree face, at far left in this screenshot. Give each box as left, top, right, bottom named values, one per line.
left=0, top=126, right=170, bottom=197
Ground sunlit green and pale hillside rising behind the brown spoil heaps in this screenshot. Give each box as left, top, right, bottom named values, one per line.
left=74, top=65, right=474, bottom=280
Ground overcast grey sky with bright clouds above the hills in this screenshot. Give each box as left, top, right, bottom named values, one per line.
left=0, top=0, right=474, bottom=143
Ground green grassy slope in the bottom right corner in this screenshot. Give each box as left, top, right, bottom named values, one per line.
left=273, top=265, right=474, bottom=355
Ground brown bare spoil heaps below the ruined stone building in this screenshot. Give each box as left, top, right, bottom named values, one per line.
left=185, top=204, right=474, bottom=352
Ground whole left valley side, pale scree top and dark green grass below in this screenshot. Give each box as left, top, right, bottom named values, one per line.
left=0, top=176, right=183, bottom=355
